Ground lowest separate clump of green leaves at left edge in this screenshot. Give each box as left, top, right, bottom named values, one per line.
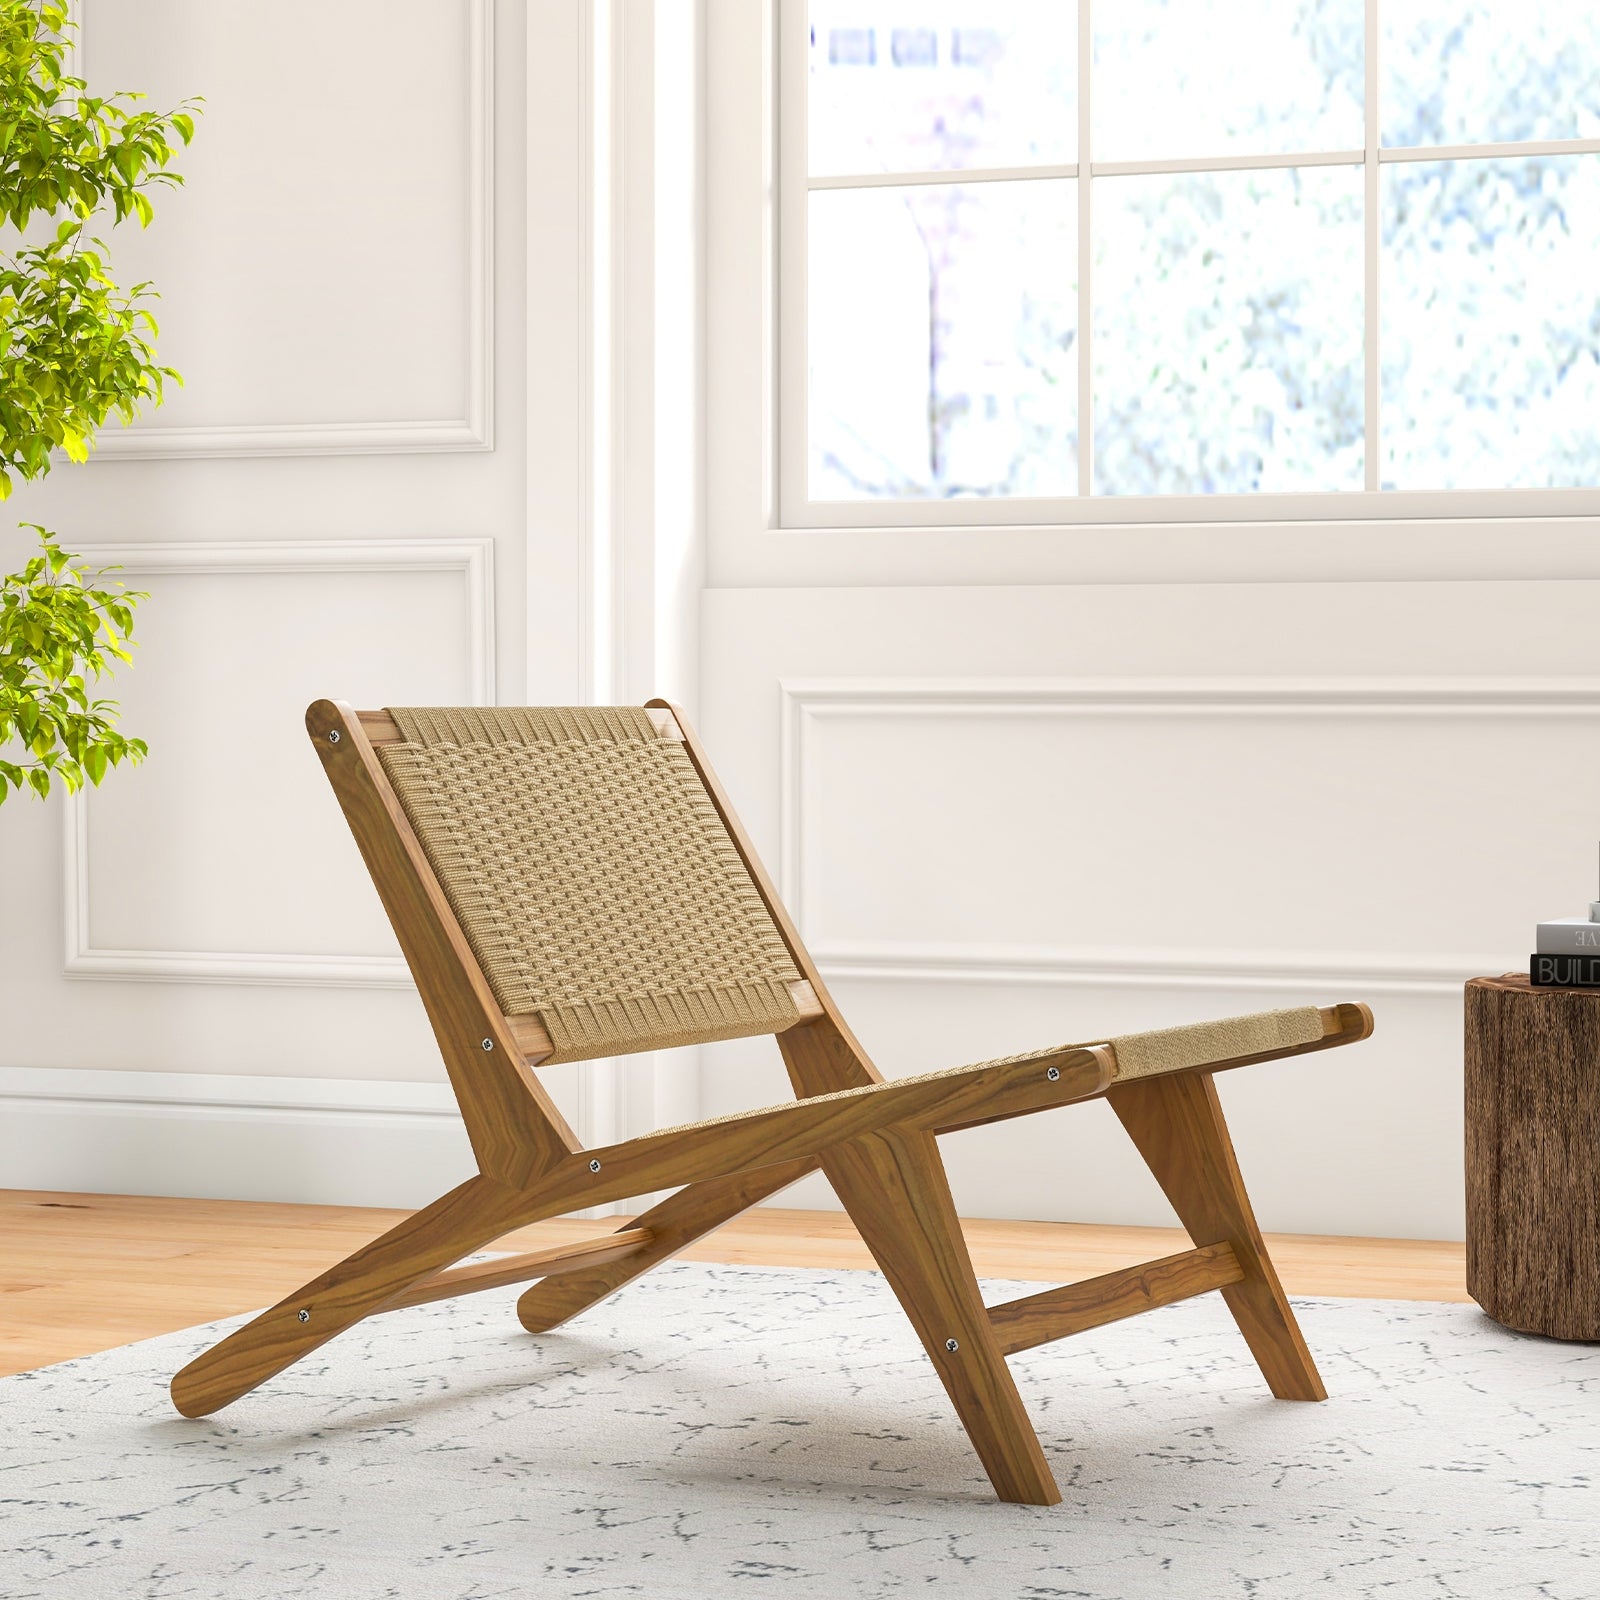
left=0, top=523, right=147, bottom=800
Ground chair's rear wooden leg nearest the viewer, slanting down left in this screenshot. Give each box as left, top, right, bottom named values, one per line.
left=173, top=1178, right=540, bottom=1416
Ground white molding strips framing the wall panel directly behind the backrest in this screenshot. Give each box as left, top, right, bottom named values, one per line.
left=62, top=539, right=494, bottom=989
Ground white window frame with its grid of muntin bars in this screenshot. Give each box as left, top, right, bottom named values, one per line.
left=773, top=0, right=1600, bottom=530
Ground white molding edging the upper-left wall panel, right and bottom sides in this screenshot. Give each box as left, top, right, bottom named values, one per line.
left=78, top=0, right=494, bottom=461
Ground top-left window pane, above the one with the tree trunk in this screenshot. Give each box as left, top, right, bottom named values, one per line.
left=810, top=0, right=1078, bottom=173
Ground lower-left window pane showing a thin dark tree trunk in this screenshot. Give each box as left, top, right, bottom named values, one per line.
left=810, top=179, right=1078, bottom=499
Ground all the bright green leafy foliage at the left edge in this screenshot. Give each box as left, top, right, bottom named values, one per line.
left=0, top=0, right=198, bottom=802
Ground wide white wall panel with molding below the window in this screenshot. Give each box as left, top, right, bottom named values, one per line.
left=781, top=678, right=1600, bottom=997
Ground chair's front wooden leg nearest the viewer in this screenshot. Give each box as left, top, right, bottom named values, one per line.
left=822, top=1128, right=1061, bottom=1506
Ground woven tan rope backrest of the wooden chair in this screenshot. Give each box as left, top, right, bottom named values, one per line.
left=378, top=706, right=800, bottom=1061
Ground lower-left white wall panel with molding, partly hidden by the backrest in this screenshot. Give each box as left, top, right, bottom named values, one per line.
left=64, top=539, right=494, bottom=987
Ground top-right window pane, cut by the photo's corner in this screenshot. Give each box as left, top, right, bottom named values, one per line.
left=1381, top=0, right=1600, bottom=146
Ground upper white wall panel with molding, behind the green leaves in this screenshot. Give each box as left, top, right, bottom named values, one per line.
left=83, top=0, right=494, bottom=459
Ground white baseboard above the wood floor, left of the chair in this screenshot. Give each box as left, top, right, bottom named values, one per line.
left=0, top=1067, right=475, bottom=1206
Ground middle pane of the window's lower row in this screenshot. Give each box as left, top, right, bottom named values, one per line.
left=1094, top=166, right=1363, bottom=494
